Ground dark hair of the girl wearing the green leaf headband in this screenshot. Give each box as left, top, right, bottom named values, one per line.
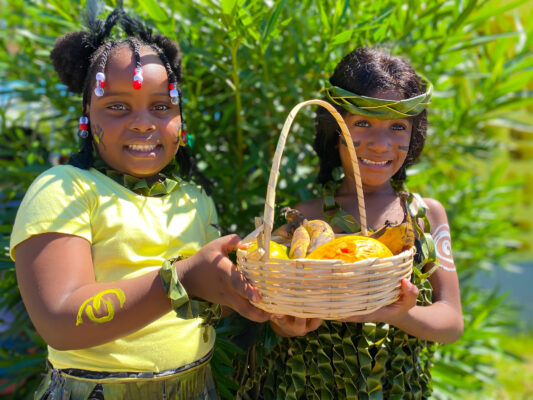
left=313, top=48, right=427, bottom=187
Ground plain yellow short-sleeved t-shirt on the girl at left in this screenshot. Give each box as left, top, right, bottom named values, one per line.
left=10, top=165, right=219, bottom=372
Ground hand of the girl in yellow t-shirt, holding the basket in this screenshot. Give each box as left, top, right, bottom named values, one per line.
left=174, top=235, right=270, bottom=322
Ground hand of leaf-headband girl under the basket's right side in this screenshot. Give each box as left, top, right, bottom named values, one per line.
left=341, top=279, right=418, bottom=325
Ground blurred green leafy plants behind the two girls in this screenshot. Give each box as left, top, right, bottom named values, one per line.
left=0, top=0, right=533, bottom=399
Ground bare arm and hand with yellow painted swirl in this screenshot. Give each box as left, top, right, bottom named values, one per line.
left=15, top=233, right=267, bottom=350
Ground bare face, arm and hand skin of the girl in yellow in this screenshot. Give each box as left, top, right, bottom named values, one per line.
left=15, top=44, right=269, bottom=350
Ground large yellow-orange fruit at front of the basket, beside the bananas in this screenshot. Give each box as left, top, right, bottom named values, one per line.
left=307, top=235, right=393, bottom=262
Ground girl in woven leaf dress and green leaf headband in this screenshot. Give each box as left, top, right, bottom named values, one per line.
left=239, top=48, right=463, bottom=400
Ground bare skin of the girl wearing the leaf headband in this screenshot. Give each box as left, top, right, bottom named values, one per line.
left=271, top=91, right=463, bottom=343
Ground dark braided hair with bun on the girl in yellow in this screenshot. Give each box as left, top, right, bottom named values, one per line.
left=50, top=2, right=211, bottom=190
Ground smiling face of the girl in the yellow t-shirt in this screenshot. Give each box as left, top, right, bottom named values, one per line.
left=88, top=46, right=181, bottom=178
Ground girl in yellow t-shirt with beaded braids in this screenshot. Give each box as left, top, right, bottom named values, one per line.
left=10, top=0, right=268, bottom=400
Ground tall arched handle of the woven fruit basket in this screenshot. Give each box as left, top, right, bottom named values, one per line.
left=262, top=99, right=368, bottom=261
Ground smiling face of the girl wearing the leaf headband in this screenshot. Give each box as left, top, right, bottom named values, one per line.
left=339, top=91, right=413, bottom=190
